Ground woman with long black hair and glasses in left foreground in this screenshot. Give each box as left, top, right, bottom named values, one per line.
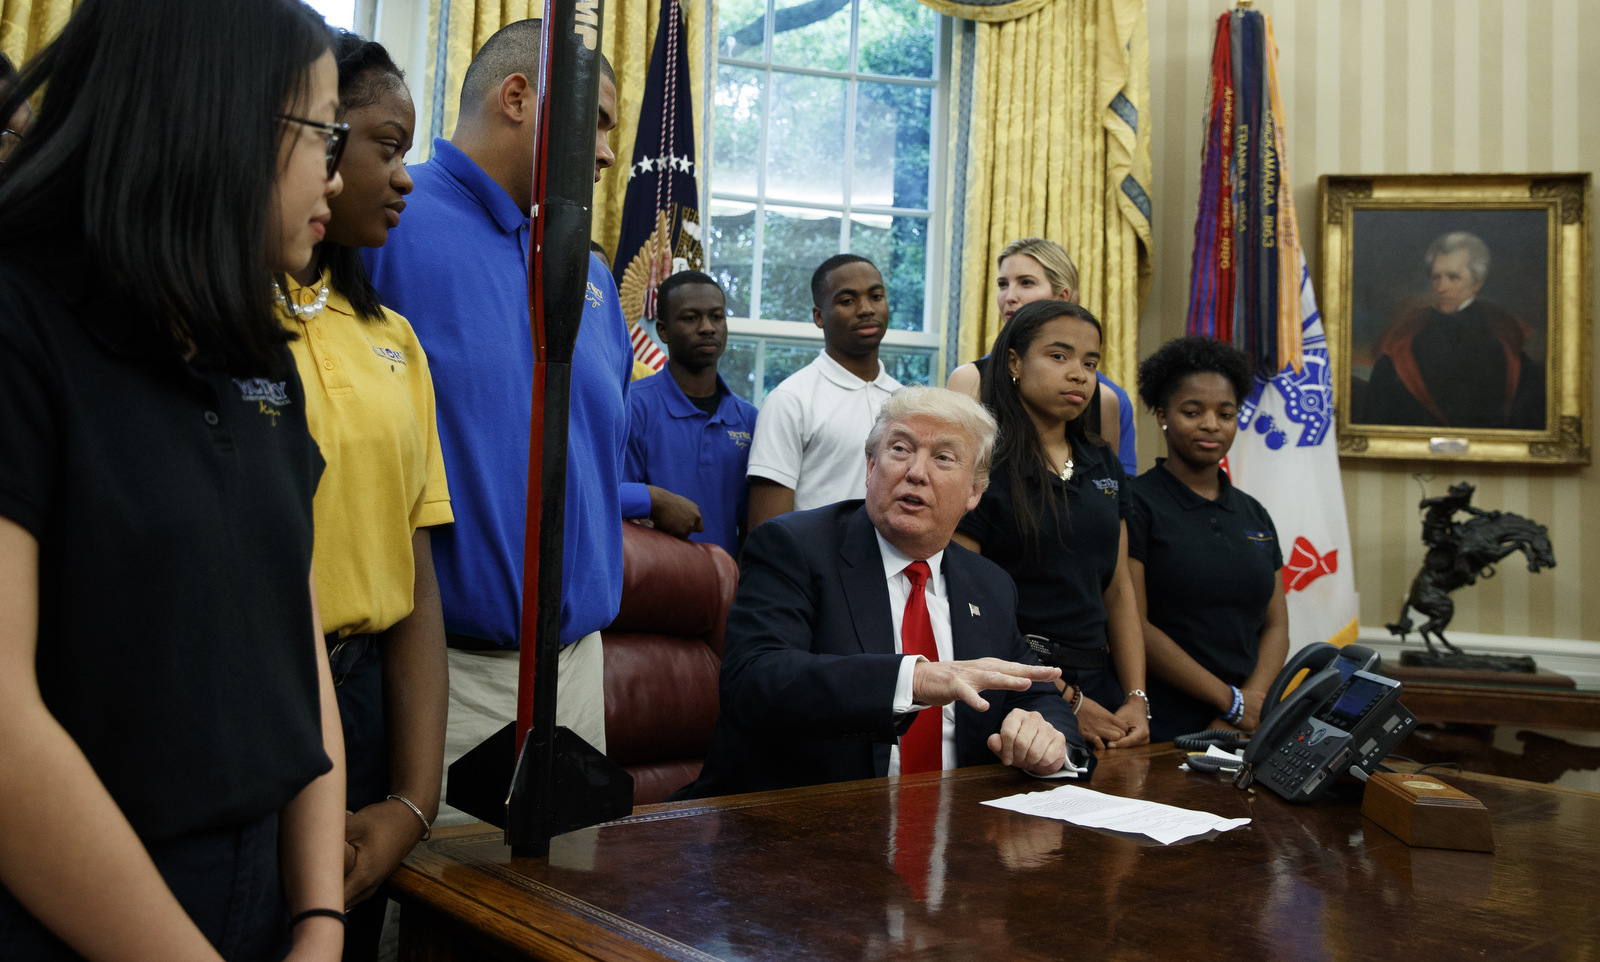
left=0, top=0, right=346, bottom=960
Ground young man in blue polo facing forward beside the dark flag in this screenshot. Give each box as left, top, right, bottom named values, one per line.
left=622, top=271, right=755, bottom=557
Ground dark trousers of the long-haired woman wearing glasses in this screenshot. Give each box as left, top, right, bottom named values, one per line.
left=0, top=812, right=290, bottom=962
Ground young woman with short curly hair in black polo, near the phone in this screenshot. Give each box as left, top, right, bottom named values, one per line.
left=1128, top=338, right=1290, bottom=741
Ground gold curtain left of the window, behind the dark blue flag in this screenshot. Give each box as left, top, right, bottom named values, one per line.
left=418, top=0, right=709, bottom=255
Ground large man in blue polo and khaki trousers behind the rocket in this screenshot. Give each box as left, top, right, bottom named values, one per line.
left=362, top=19, right=699, bottom=824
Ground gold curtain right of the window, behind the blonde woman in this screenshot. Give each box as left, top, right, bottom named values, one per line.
left=923, top=0, right=1150, bottom=386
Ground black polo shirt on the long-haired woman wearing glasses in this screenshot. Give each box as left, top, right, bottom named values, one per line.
left=0, top=259, right=331, bottom=844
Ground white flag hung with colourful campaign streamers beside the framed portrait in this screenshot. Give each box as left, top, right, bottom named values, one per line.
left=1187, top=10, right=1358, bottom=648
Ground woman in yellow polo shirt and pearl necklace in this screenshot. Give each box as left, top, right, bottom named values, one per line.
left=278, top=30, right=451, bottom=959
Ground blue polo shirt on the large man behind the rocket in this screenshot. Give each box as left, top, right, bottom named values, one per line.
left=362, top=139, right=650, bottom=648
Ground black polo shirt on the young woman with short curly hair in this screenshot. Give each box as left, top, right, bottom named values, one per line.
left=1128, top=458, right=1283, bottom=741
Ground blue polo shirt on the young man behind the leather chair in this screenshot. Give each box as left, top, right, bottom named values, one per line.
left=622, top=371, right=755, bottom=557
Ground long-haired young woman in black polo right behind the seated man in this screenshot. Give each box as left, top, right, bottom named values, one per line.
left=955, top=299, right=1150, bottom=749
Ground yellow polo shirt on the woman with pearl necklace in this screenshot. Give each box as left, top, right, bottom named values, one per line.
left=285, top=279, right=454, bottom=637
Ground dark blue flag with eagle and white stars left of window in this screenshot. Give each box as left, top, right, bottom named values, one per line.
left=613, top=0, right=706, bottom=371
